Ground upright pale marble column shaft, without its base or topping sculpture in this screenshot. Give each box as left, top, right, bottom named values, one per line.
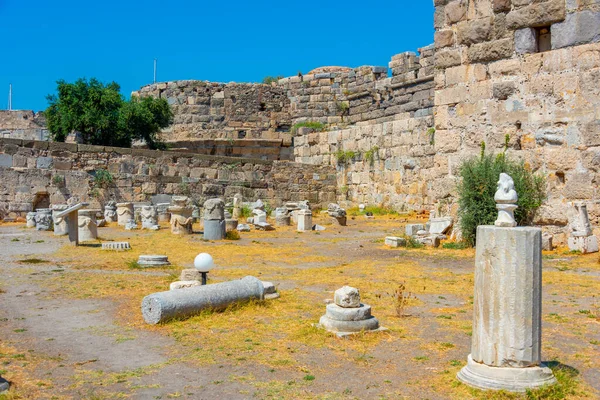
left=471, top=226, right=542, bottom=368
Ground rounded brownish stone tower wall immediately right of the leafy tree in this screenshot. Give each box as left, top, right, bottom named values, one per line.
left=133, top=80, right=291, bottom=142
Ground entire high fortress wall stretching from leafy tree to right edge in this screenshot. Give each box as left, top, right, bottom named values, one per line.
left=1, top=0, right=600, bottom=241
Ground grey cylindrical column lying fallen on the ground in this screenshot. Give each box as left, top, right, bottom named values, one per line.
left=142, top=276, right=264, bottom=324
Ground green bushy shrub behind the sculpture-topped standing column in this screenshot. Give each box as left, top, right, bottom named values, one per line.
left=458, top=141, right=546, bottom=246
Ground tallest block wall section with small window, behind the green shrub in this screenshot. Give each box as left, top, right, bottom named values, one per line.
left=435, top=0, right=600, bottom=242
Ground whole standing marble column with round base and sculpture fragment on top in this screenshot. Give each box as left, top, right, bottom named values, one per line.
left=457, top=174, right=556, bottom=392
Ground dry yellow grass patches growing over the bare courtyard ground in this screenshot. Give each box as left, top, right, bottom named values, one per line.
left=16, top=217, right=600, bottom=399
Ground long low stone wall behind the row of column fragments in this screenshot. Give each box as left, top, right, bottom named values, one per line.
left=0, top=139, right=337, bottom=217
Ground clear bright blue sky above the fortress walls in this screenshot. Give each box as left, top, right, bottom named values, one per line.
left=0, top=0, right=433, bottom=111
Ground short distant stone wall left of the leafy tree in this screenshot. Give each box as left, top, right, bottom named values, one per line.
left=0, top=110, right=48, bottom=140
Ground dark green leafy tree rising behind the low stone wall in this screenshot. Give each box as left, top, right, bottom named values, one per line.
left=45, top=78, right=173, bottom=149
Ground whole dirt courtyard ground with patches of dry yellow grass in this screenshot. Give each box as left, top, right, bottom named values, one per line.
left=0, top=216, right=600, bottom=399
